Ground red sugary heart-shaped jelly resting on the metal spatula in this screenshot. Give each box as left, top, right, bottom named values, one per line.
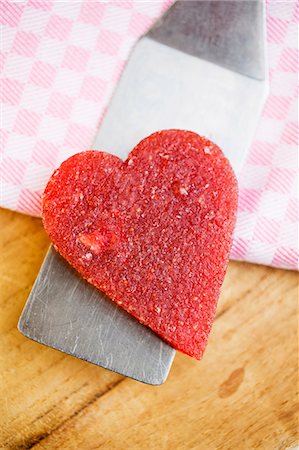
left=43, top=130, right=237, bottom=359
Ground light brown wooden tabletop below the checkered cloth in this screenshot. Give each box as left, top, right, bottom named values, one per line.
left=0, top=210, right=298, bottom=450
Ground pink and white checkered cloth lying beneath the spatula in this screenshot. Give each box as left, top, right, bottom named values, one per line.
left=0, top=0, right=298, bottom=269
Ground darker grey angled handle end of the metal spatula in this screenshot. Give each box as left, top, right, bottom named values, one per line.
left=148, top=0, right=265, bottom=79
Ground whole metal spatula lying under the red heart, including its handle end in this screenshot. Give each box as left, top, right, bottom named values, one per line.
left=18, top=0, right=267, bottom=384
